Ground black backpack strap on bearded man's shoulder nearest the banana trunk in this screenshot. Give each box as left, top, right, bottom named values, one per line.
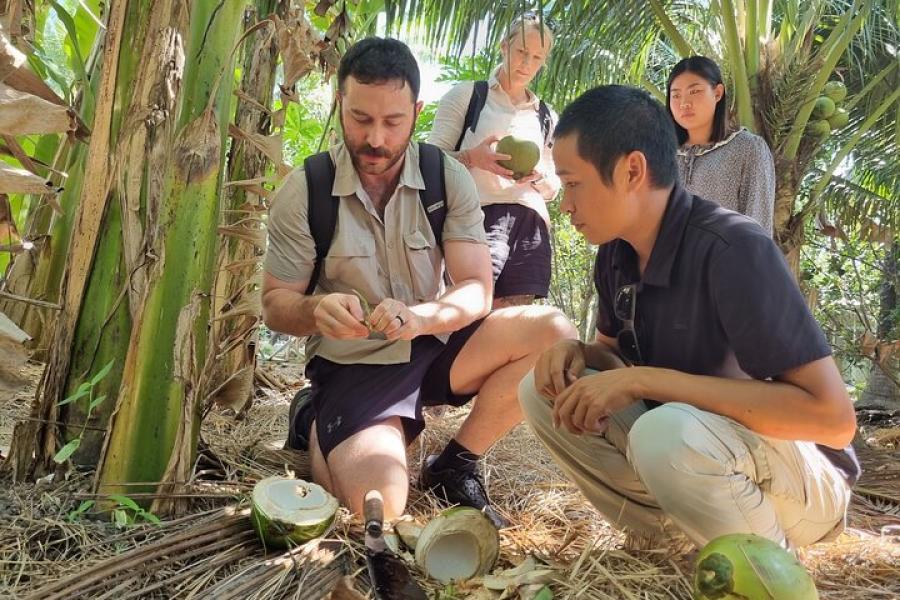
left=303, top=152, right=339, bottom=294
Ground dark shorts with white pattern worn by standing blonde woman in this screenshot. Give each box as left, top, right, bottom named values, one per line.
left=482, top=204, right=552, bottom=298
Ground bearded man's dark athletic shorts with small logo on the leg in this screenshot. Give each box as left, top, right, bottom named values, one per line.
left=306, top=319, right=483, bottom=458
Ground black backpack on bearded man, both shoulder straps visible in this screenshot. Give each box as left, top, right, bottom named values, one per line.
left=303, top=142, right=447, bottom=294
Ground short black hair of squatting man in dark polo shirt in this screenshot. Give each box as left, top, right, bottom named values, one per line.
left=553, top=85, right=678, bottom=188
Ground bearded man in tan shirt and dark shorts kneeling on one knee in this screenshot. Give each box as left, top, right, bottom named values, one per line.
left=263, top=38, right=577, bottom=526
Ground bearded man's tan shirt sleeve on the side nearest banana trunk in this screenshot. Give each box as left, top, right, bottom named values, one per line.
left=265, top=167, right=316, bottom=282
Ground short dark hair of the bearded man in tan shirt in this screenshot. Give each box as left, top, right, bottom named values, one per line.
left=338, top=37, right=421, bottom=101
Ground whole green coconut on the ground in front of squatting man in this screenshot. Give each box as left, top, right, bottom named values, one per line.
left=694, top=533, right=819, bottom=600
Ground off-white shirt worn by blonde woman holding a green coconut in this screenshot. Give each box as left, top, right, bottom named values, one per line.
left=428, top=68, right=560, bottom=224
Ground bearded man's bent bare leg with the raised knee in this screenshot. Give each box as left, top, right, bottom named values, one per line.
left=450, top=306, right=578, bottom=454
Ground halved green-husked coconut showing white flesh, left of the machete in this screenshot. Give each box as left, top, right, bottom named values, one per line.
left=250, top=477, right=338, bottom=548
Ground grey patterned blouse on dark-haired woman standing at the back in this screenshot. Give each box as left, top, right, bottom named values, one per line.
left=678, top=128, right=775, bottom=236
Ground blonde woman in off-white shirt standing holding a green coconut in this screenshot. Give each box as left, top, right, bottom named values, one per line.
left=429, top=13, right=560, bottom=308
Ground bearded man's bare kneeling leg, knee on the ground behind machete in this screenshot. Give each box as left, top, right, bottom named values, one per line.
left=310, top=417, right=409, bottom=519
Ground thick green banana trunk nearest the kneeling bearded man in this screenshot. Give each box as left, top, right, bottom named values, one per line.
left=97, top=0, right=244, bottom=512
